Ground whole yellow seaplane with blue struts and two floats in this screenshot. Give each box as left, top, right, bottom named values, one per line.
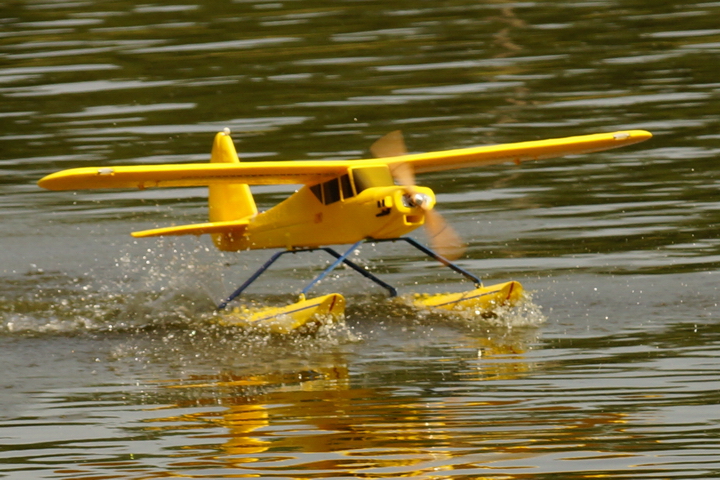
left=38, top=125, right=652, bottom=333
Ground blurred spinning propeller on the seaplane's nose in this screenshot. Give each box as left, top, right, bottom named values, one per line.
left=370, top=130, right=465, bottom=260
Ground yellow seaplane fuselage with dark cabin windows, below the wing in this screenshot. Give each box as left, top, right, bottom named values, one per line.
left=210, top=165, right=435, bottom=251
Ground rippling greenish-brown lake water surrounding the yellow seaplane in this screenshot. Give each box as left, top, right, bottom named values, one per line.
left=0, top=0, right=720, bottom=479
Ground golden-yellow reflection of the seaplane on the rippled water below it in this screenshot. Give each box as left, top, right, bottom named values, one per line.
left=138, top=330, right=625, bottom=478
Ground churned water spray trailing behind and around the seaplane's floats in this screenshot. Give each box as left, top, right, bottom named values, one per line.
left=0, top=232, right=545, bottom=344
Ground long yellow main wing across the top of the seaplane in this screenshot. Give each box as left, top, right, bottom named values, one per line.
left=38, top=130, right=652, bottom=190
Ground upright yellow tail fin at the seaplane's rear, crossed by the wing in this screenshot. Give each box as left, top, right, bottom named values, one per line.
left=208, top=129, right=257, bottom=251
